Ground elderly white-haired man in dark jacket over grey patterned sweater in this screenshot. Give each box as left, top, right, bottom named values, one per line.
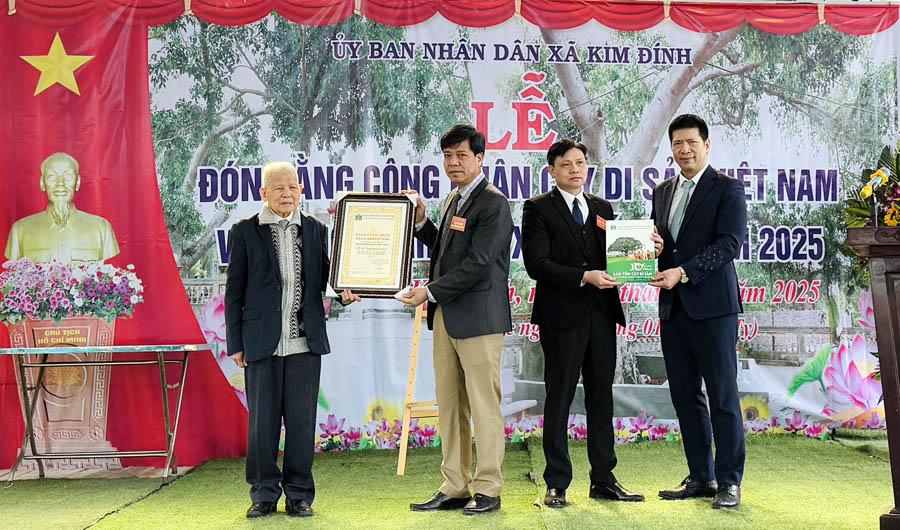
left=225, top=162, right=359, bottom=518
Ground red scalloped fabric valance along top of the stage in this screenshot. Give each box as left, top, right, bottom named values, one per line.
left=3, top=0, right=898, bottom=35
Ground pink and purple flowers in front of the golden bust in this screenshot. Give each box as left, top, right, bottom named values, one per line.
left=0, top=258, right=144, bottom=324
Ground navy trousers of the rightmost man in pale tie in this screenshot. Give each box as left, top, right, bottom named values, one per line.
left=660, top=296, right=746, bottom=486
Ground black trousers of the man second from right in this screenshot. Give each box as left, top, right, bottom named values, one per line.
left=541, top=307, right=616, bottom=489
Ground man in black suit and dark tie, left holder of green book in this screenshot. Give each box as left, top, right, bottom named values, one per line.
left=522, top=140, right=659, bottom=508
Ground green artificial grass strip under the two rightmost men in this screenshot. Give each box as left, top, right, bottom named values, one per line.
left=531, top=435, right=892, bottom=530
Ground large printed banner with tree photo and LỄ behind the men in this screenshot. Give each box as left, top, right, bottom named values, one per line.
left=158, top=16, right=897, bottom=450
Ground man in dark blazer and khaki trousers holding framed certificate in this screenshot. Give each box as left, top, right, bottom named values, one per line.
left=401, top=125, right=512, bottom=515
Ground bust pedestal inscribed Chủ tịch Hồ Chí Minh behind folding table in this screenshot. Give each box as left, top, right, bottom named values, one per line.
left=7, top=317, right=121, bottom=470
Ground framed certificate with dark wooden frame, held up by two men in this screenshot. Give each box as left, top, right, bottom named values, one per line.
left=330, top=193, right=416, bottom=298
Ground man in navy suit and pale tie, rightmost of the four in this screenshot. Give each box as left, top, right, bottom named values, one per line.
left=650, top=114, right=747, bottom=508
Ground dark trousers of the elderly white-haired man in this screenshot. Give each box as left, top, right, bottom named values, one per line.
left=244, top=353, right=322, bottom=504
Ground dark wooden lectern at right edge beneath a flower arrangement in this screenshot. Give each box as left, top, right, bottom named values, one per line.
left=847, top=227, right=900, bottom=530
